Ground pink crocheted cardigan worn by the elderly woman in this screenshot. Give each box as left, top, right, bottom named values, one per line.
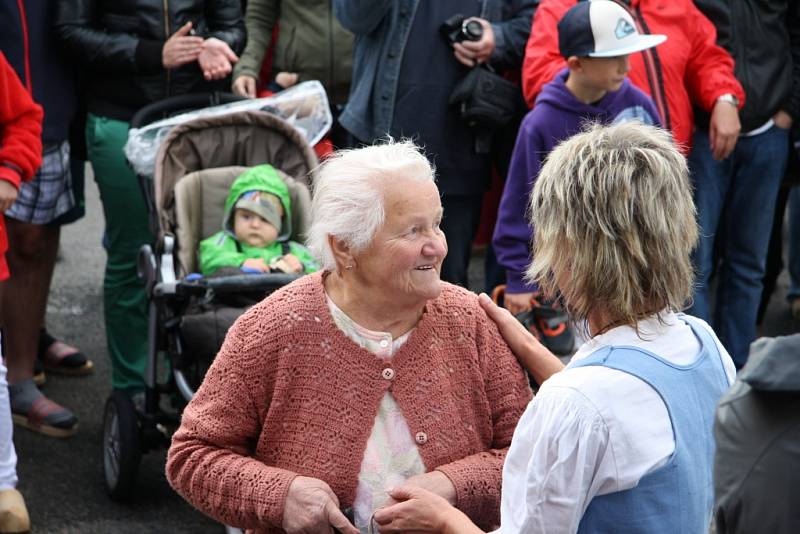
left=167, top=273, right=531, bottom=534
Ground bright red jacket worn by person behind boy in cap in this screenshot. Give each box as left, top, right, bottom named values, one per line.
left=522, top=0, right=745, bottom=152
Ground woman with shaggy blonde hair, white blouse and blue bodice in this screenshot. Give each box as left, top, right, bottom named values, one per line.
left=375, top=123, right=735, bottom=534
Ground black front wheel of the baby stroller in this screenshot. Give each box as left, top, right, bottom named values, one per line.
left=103, top=390, right=142, bottom=501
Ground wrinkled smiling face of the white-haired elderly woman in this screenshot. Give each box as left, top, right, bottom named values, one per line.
left=354, top=179, right=447, bottom=305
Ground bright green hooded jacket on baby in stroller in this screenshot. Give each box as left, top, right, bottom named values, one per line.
left=200, top=165, right=319, bottom=276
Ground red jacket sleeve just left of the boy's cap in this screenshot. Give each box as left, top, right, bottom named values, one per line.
left=522, top=0, right=575, bottom=107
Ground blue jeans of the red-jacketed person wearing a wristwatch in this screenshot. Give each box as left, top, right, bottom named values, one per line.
left=688, top=126, right=789, bottom=368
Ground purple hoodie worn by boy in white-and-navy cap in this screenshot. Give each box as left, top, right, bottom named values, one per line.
left=492, top=69, right=661, bottom=293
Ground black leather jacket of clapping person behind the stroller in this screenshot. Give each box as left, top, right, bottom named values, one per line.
left=55, top=0, right=245, bottom=120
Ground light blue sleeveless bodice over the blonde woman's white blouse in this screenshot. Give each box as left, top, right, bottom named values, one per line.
left=569, top=315, right=728, bottom=534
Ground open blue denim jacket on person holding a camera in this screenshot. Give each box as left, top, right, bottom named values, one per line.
left=333, top=0, right=537, bottom=142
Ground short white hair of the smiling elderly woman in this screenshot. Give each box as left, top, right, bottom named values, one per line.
left=306, top=138, right=434, bottom=271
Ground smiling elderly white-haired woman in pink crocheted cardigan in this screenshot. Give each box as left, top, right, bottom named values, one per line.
left=167, top=141, right=531, bottom=534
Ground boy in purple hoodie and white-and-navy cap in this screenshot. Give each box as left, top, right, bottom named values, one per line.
left=493, top=0, right=666, bottom=318
